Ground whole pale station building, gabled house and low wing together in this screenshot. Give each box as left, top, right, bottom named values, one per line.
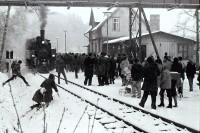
left=86, top=8, right=196, bottom=61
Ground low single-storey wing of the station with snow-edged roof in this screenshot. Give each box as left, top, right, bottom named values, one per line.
left=103, top=31, right=196, bottom=61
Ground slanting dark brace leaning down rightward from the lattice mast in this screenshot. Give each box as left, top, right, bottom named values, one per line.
left=140, top=7, right=160, bottom=58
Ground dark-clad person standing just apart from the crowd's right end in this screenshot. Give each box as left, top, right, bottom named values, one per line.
left=186, top=60, right=196, bottom=91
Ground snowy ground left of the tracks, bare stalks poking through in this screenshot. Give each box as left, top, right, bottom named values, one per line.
left=0, top=74, right=108, bottom=133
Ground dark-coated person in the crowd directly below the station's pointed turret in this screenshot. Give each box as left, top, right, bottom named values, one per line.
left=83, top=53, right=94, bottom=85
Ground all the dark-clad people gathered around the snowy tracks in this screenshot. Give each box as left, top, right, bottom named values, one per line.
left=3, top=52, right=200, bottom=109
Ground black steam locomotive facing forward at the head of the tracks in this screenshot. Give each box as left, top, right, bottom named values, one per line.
left=26, top=30, right=56, bottom=73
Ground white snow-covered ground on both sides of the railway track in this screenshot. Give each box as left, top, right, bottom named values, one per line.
left=0, top=72, right=200, bottom=133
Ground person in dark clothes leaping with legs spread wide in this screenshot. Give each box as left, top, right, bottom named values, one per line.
left=2, top=60, right=30, bottom=86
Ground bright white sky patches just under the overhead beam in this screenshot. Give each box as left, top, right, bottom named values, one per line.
left=50, top=7, right=196, bottom=32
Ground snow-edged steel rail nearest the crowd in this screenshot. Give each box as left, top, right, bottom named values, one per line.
left=55, top=75, right=200, bottom=133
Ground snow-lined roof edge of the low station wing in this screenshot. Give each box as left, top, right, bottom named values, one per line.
left=104, top=31, right=195, bottom=44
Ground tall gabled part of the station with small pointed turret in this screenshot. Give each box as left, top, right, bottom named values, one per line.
left=85, top=8, right=146, bottom=54
